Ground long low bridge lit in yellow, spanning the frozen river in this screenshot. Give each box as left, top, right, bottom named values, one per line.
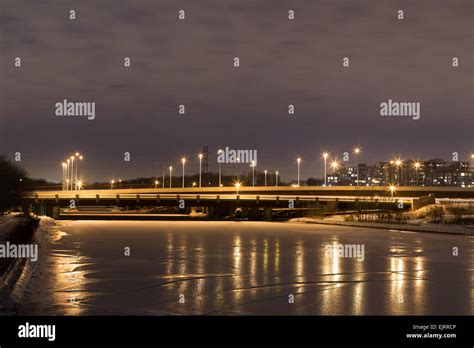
left=26, top=186, right=474, bottom=218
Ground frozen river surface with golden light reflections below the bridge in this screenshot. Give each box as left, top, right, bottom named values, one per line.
left=19, top=220, right=474, bottom=315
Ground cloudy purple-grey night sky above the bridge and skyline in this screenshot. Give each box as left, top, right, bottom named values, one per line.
left=0, top=0, right=474, bottom=181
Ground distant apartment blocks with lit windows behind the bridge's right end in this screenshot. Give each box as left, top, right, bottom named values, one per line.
left=327, top=159, right=474, bottom=187
